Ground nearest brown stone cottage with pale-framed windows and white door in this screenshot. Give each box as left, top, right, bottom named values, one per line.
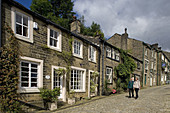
left=1, top=0, right=100, bottom=105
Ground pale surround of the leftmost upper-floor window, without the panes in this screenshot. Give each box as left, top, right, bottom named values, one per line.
left=11, top=7, right=33, bottom=43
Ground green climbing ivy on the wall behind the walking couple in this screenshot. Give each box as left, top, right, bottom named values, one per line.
left=114, top=49, right=137, bottom=90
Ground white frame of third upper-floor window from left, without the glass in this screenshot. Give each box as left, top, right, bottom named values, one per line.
left=72, top=38, right=83, bottom=58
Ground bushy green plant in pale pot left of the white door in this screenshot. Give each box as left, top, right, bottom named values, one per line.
left=40, top=88, right=60, bottom=110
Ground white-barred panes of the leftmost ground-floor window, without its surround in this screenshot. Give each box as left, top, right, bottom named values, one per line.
left=20, top=61, right=38, bottom=88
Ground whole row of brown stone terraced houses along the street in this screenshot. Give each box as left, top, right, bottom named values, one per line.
left=1, top=0, right=170, bottom=108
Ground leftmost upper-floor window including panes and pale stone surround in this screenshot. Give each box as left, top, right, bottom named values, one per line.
left=11, top=7, right=33, bottom=43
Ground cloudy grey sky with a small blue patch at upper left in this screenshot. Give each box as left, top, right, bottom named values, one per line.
left=16, top=0, right=170, bottom=52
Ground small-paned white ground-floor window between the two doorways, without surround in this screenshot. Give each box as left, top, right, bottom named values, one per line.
left=71, top=69, right=85, bottom=91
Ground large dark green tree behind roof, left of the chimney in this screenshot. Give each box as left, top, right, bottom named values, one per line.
left=30, top=0, right=75, bottom=29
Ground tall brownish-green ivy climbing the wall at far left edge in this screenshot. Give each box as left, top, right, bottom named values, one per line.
left=0, top=25, right=21, bottom=113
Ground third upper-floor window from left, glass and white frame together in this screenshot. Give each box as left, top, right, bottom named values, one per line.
left=73, top=39, right=83, bottom=58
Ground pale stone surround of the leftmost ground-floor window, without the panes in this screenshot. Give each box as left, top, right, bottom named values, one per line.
left=18, top=56, right=43, bottom=93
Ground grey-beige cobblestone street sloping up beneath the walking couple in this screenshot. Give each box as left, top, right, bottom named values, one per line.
left=55, top=85, right=170, bottom=113
